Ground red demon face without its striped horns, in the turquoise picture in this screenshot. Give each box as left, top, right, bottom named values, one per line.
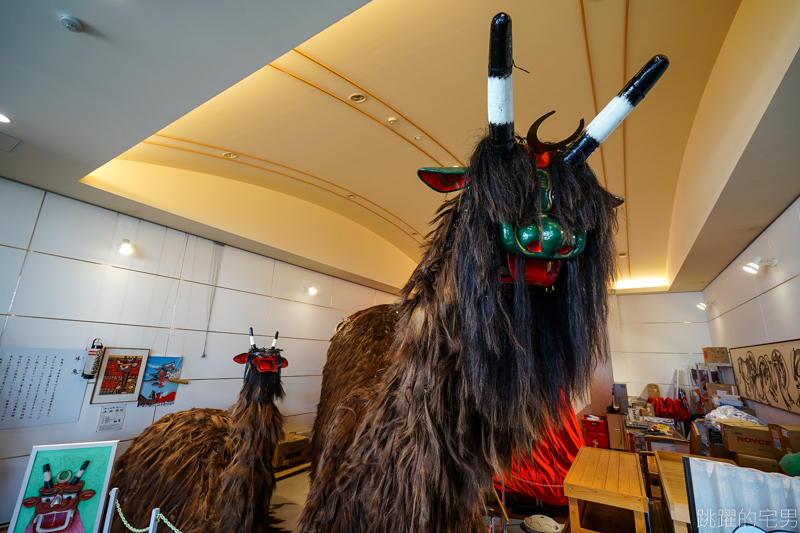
left=22, top=471, right=95, bottom=533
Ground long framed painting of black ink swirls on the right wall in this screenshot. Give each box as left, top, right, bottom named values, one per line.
left=731, top=339, right=800, bottom=413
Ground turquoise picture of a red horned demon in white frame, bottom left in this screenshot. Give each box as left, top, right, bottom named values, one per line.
left=8, top=441, right=119, bottom=533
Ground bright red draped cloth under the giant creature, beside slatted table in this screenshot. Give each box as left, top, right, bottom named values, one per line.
left=494, top=406, right=586, bottom=505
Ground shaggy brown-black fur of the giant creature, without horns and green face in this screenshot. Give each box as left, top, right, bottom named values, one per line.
left=299, top=140, right=616, bottom=533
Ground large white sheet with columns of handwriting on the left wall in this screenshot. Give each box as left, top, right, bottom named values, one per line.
left=0, top=347, right=86, bottom=429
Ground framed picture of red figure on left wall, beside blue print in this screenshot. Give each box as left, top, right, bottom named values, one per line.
left=91, top=348, right=150, bottom=403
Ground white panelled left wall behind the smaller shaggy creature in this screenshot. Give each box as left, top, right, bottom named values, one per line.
left=0, top=179, right=395, bottom=523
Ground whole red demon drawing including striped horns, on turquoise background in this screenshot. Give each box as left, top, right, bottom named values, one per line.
left=22, top=461, right=96, bottom=533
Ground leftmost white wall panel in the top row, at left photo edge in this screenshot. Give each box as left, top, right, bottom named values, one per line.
left=0, top=179, right=44, bottom=248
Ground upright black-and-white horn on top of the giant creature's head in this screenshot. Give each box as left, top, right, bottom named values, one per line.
left=487, top=13, right=515, bottom=153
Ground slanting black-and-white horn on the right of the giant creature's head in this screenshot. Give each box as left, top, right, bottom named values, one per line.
left=564, top=55, right=669, bottom=166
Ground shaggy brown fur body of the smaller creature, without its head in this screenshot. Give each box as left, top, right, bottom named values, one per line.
left=111, top=363, right=283, bottom=533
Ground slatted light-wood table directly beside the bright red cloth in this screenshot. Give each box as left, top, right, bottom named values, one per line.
left=564, top=446, right=648, bottom=533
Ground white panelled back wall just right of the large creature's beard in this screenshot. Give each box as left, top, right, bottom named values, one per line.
left=609, top=292, right=711, bottom=401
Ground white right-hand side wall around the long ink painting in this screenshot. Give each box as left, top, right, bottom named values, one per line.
left=703, top=195, right=800, bottom=424
